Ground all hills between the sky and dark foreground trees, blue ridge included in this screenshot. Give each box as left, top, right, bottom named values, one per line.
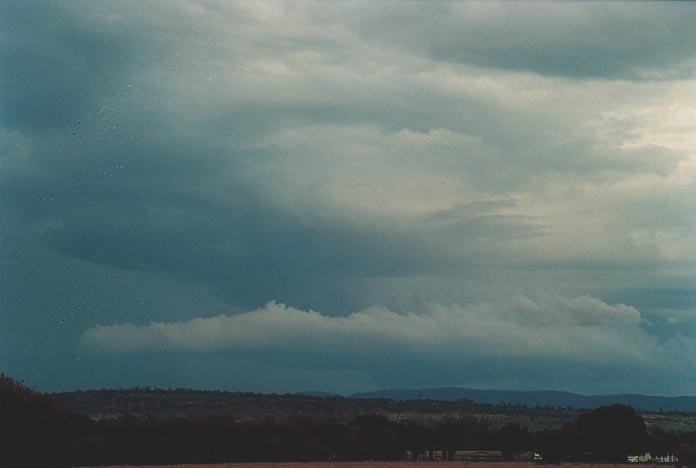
left=47, top=387, right=696, bottom=431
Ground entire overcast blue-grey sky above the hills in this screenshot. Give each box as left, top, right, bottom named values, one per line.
left=0, top=0, right=696, bottom=395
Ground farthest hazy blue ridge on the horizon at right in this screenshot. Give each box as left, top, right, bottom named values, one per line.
left=351, top=387, right=696, bottom=413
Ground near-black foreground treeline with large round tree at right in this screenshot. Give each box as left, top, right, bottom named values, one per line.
left=0, top=375, right=696, bottom=467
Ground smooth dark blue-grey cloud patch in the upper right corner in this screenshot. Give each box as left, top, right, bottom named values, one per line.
left=340, top=2, right=696, bottom=80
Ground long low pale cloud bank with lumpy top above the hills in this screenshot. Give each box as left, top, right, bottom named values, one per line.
left=80, top=295, right=666, bottom=372
